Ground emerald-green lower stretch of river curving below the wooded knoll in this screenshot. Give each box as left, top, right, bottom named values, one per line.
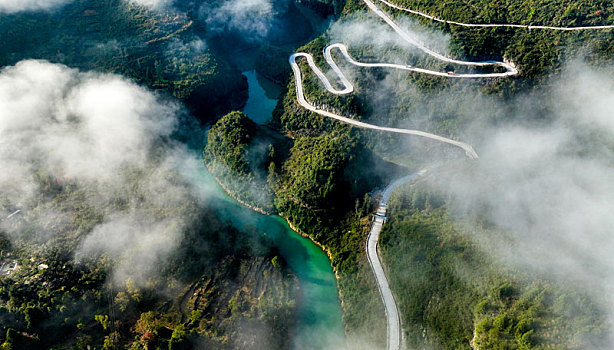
left=203, top=168, right=346, bottom=350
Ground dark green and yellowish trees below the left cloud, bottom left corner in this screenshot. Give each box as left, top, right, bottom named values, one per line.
left=0, top=230, right=297, bottom=349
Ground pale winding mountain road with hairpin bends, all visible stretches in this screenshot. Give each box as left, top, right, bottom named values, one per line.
left=289, top=0, right=614, bottom=350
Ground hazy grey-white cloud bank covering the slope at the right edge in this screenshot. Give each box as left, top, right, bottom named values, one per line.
left=422, top=62, right=614, bottom=334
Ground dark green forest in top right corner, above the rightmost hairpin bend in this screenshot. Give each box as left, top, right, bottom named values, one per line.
left=366, top=0, right=614, bottom=80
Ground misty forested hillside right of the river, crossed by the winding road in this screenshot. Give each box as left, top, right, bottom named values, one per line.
left=203, top=0, right=614, bottom=349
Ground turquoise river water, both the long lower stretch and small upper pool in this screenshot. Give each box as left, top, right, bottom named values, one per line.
left=188, top=72, right=345, bottom=350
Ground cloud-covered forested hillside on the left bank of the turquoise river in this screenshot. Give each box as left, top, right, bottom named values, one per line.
left=0, top=51, right=300, bottom=349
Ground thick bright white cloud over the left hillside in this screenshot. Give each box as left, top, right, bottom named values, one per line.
left=0, top=60, right=205, bottom=282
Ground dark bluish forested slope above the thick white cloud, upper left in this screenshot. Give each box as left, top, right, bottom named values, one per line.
left=0, top=0, right=247, bottom=118
